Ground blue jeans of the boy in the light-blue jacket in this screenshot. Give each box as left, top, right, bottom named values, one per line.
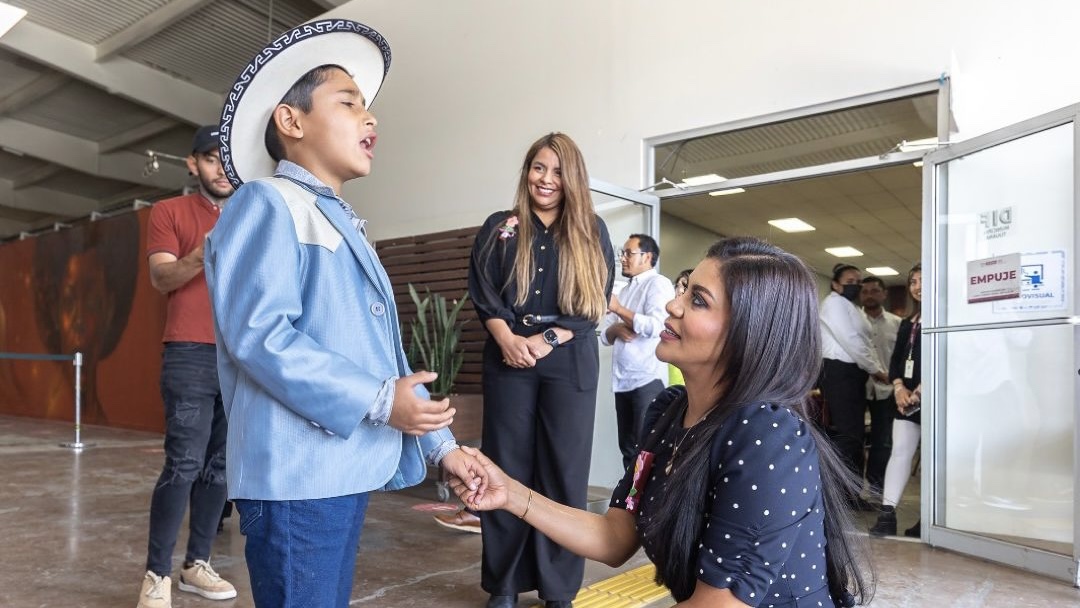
left=233, top=492, right=369, bottom=608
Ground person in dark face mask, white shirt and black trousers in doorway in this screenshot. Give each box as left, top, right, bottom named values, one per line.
left=820, top=264, right=889, bottom=509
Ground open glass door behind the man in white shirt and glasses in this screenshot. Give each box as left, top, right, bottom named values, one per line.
left=589, top=179, right=663, bottom=488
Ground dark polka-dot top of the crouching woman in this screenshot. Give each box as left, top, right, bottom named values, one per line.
left=610, top=387, right=835, bottom=607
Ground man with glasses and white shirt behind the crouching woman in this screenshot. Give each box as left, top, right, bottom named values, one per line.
left=599, top=234, right=675, bottom=468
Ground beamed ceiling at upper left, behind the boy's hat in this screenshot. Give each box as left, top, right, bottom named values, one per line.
left=0, top=0, right=346, bottom=240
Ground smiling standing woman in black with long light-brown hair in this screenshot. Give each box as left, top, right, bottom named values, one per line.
left=469, top=133, right=615, bottom=608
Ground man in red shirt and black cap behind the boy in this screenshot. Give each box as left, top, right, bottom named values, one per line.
left=138, top=126, right=237, bottom=608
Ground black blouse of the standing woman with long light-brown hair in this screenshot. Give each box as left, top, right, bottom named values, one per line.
left=469, top=211, right=615, bottom=346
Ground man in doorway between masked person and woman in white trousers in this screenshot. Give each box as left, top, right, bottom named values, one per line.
left=859, top=276, right=900, bottom=492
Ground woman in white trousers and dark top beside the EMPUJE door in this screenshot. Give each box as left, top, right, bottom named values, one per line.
left=869, top=264, right=922, bottom=538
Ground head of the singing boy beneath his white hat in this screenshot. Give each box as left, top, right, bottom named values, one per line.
left=285, top=68, right=378, bottom=192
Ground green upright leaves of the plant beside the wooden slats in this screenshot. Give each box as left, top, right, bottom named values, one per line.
left=407, top=283, right=469, bottom=400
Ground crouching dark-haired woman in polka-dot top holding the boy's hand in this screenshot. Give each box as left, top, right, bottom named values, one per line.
left=451, top=238, right=872, bottom=607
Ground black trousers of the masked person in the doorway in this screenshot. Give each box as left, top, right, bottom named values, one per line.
left=821, top=359, right=869, bottom=479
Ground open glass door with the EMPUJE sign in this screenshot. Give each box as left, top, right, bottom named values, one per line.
left=922, top=106, right=1080, bottom=584
